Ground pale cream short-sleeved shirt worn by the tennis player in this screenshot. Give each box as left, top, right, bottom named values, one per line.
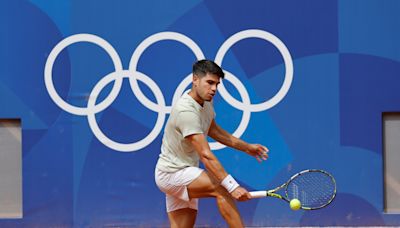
left=157, top=92, right=215, bottom=172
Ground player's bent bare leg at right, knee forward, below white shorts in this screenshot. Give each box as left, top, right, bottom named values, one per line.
left=188, top=171, right=243, bottom=227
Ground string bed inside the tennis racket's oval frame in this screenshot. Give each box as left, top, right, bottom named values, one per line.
left=286, top=172, right=336, bottom=208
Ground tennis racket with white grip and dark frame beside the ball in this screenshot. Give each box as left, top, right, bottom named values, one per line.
left=250, top=169, right=336, bottom=210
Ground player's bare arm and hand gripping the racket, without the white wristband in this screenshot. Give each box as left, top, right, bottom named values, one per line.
left=185, top=134, right=251, bottom=201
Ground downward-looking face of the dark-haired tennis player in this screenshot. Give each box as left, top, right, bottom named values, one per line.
left=193, top=74, right=220, bottom=101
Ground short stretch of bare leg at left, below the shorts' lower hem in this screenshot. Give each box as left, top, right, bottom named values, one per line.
left=168, top=208, right=197, bottom=228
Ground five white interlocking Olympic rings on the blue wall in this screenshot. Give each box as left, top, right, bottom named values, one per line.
left=44, top=29, right=293, bottom=152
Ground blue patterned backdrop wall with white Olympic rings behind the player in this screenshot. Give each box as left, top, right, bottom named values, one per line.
left=0, top=0, right=400, bottom=227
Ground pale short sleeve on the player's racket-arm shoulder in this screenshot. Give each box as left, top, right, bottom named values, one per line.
left=176, top=111, right=204, bottom=137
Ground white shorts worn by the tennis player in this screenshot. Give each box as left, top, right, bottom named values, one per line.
left=155, top=167, right=204, bottom=212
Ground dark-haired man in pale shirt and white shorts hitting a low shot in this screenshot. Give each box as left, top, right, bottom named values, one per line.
left=155, top=60, right=268, bottom=228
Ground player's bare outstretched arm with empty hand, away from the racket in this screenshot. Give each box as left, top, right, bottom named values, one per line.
left=208, top=119, right=268, bottom=162
